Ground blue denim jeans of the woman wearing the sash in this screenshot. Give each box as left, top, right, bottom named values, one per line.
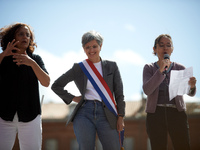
left=73, top=100, right=120, bottom=150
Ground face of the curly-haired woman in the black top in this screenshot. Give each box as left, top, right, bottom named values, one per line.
left=15, top=26, right=31, bottom=50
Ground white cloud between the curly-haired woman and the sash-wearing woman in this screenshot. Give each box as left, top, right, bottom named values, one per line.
left=38, top=49, right=85, bottom=103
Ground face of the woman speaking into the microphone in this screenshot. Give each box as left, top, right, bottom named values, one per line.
left=153, top=37, right=173, bottom=60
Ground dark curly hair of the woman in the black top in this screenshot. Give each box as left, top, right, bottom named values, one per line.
left=0, top=23, right=37, bottom=53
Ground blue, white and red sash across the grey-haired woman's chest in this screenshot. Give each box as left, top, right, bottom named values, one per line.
left=79, top=59, right=118, bottom=116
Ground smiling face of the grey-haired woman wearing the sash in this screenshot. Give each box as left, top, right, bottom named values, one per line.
left=83, top=40, right=102, bottom=63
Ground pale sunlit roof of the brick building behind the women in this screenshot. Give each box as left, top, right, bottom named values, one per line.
left=42, top=101, right=200, bottom=120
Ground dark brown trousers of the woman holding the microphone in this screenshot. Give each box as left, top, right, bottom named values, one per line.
left=146, top=106, right=190, bottom=150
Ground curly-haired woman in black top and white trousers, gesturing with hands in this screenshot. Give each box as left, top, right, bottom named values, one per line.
left=0, top=23, right=50, bottom=150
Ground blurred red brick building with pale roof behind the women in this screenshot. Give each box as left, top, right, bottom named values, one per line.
left=13, top=99, right=200, bottom=150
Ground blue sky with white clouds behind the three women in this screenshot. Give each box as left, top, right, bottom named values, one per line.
left=0, top=0, right=200, bottom=102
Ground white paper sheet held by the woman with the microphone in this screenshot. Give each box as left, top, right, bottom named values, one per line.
left=169, top=67, right=193, bottom=100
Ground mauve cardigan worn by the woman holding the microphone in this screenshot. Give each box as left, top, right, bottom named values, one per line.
left=143, top=62, right=196, bottom=113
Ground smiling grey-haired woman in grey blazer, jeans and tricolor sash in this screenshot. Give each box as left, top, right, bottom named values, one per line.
left=52, top=31, right=125, bottom=150
